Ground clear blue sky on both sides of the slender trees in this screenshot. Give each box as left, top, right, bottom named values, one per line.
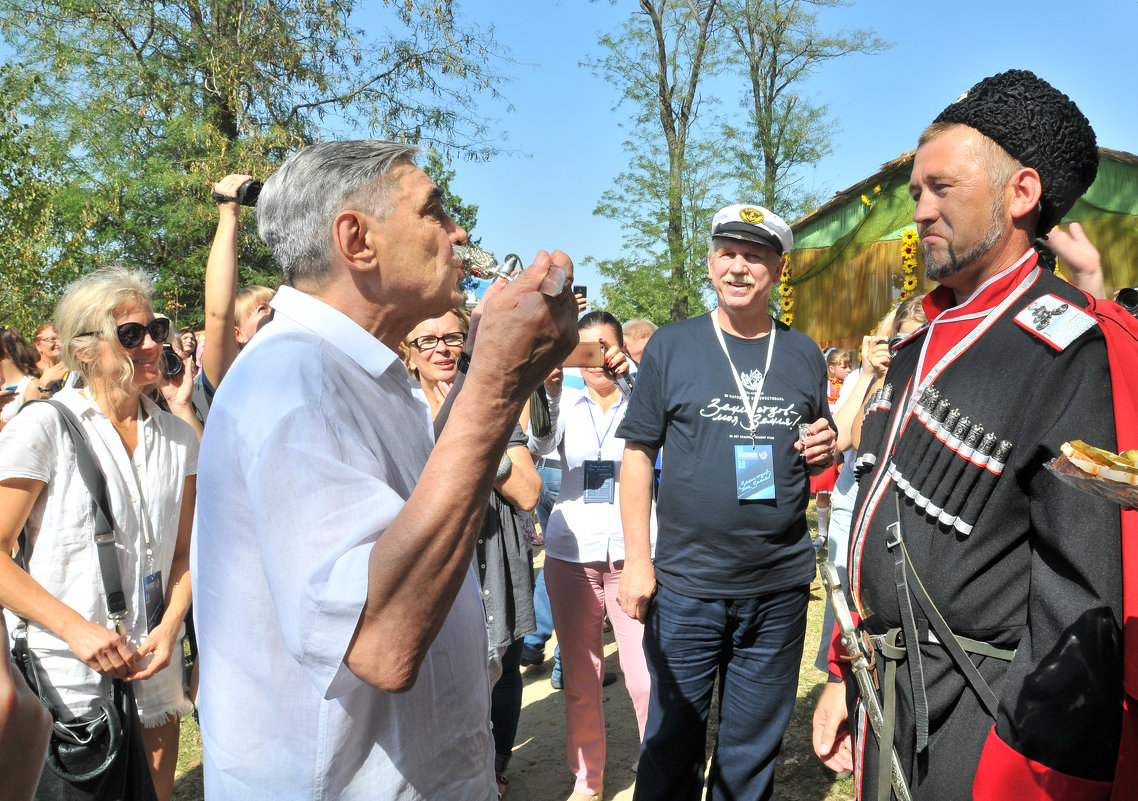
left=430, top=0, right=1138, bottom=296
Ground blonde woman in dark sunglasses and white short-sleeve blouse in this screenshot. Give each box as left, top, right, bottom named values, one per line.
left=0, top=269, right=198, bottom=801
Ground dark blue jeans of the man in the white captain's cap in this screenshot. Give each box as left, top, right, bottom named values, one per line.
left=633, top=586, right=809, bottom=801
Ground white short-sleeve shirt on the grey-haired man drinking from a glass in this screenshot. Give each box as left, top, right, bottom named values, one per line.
left=191, top=287, right=496, bottom=801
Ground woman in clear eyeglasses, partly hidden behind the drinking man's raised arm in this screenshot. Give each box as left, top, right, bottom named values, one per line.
left=404, top=309, right=542, bottom=798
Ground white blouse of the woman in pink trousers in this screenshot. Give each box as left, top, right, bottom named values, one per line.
left=545, top=387, right=655, bottom=563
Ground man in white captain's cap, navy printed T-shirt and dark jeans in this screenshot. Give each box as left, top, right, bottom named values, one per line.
left=617, top=204, right=834, bottom=801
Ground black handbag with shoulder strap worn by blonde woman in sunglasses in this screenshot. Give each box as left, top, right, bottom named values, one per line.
left=13, top=401, right=157, bottom=801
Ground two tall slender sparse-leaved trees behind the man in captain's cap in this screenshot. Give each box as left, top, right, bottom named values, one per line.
left=586, top=0, right=889, bottom=323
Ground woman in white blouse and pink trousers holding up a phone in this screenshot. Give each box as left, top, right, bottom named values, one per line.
left=545, top=311, right=655, bottom=801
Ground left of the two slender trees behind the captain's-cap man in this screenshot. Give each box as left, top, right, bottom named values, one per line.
left=586, top=0, right=717, bottom=323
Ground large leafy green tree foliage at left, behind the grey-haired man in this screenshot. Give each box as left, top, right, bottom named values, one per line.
left=0, top=0, right=512, bottom=324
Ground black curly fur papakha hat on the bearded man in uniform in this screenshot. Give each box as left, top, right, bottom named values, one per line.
left=934, top=69, right=1098, bottom=236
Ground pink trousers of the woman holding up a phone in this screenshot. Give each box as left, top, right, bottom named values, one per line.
left=545, top=556, right=651, bottom=794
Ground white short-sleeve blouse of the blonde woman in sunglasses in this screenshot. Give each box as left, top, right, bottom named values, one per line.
left=0, top=388, right=198, bottom=716
